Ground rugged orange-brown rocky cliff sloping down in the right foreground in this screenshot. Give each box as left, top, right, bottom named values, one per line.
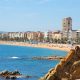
left=40, top=46, right=80, bottom=80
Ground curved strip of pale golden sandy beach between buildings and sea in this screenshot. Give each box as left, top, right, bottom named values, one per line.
left=0, top=41, right=75, bottom=52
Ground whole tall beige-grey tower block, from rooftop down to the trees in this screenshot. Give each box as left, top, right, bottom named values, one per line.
left=62, top=17, right=72, bottom=43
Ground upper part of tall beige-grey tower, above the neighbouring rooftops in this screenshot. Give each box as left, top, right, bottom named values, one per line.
left=62, top=17, right=72, bottom=32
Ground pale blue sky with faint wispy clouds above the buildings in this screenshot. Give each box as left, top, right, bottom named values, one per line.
left=0, top=0, right=80, bottom=32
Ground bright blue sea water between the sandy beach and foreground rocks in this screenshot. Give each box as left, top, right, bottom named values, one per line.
left=0, top=45, right=67, bottom=80
